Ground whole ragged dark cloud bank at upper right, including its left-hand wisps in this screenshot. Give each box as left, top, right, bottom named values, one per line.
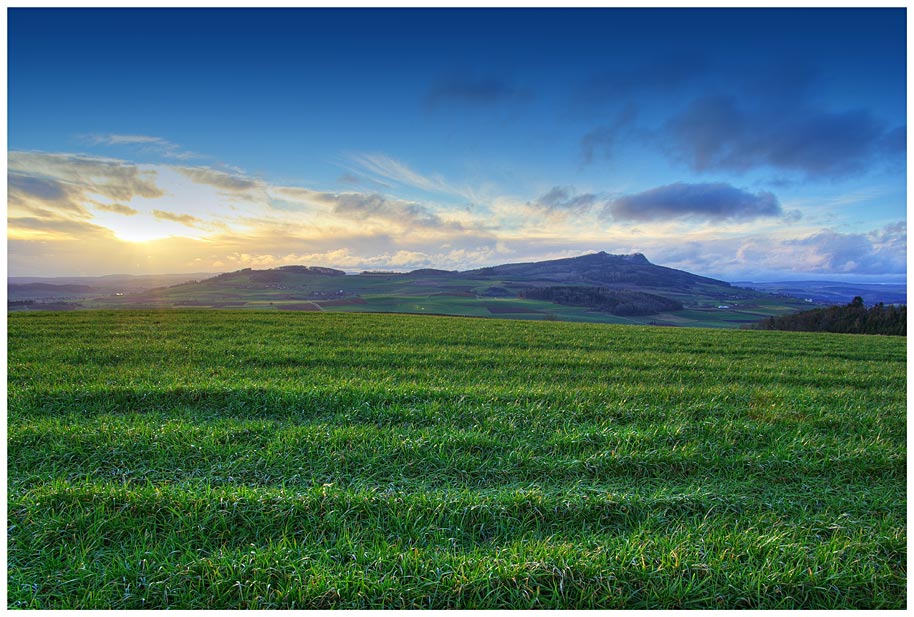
left=580, top=58, right=907, bottom=180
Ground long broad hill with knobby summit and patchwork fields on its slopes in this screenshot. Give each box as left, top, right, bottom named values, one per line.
left=15, top=252, right=808, bottom=327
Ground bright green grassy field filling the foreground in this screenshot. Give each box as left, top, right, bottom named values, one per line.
left=8, top=310, right=907, bottom=609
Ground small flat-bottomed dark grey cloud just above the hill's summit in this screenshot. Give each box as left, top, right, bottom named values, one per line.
left=604, top=182, right=782, bottom=221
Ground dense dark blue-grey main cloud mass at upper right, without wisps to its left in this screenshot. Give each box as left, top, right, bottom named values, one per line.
left=657, top=95, right=900, bottom=178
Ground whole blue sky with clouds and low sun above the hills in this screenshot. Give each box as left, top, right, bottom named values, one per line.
left=7, top=8, right=907, bottom=282
